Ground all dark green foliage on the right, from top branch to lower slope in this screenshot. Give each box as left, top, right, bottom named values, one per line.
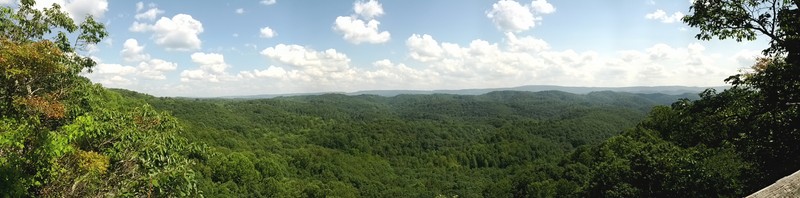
left=567, top=0, right=800, bottom=197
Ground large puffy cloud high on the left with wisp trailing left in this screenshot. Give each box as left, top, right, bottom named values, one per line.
left=129, top=14, right=203, bottom=51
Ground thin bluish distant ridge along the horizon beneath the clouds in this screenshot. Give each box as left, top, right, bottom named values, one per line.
left=227, top=85, right=728, bottom=99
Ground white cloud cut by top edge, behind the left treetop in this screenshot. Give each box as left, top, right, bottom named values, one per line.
left=33, top=0, right=108, bottom=23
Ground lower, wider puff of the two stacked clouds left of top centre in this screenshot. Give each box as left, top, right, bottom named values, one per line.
left=334, top=16, right=391, bottom=44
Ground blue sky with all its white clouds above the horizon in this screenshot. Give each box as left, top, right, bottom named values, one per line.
left=0, top=0, right=768, bottom=97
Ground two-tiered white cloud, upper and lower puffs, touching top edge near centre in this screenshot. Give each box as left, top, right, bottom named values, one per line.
left=333, top=0, right=391, bottom=44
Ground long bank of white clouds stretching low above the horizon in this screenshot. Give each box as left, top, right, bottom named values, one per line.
left=162, top=33, right=757, bottom=95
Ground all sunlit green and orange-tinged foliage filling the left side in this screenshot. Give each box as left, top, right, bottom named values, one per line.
left=0, top=0, right=205, bottom=197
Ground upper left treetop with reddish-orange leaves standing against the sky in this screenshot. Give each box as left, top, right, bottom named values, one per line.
left=0, top=0, right=108, bottom=117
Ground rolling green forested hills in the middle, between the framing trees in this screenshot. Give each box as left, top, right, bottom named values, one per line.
left=116, top=90, right=683, bottom=197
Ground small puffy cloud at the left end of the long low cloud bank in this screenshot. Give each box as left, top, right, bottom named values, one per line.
left=181, top=52, right=230, bottom=82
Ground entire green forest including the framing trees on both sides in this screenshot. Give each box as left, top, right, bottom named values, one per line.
left=0, top=0, right=800, bottom=197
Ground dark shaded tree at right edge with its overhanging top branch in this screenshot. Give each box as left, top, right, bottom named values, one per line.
left=679, top=0, right=800, bottom=185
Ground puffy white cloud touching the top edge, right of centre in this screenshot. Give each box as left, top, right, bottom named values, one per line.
left=486, top=0, right=556, bottom=32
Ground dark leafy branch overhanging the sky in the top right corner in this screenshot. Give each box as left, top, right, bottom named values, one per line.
left=683, top=0, right=800, bottom=63
